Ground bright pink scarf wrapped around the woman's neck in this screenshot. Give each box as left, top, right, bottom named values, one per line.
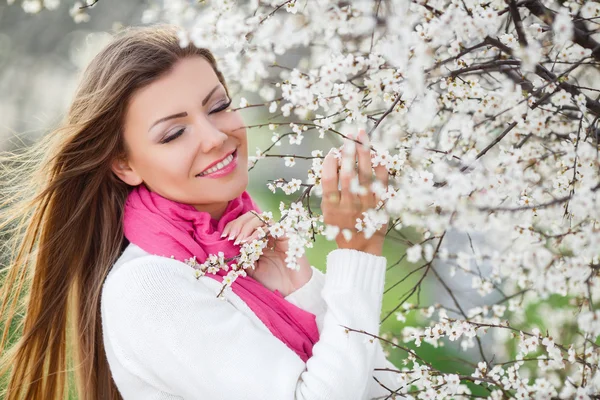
left=123, top=184, right=319, bottom=362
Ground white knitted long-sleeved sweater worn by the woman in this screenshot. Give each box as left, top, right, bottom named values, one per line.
left=101, top=244, right=399, bottom=400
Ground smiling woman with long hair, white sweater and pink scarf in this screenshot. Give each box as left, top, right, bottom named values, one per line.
left=0, top=26, right=397, bottom=400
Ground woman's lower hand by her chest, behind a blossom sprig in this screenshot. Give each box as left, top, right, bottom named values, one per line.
left=222, top=212, right=312, bottom=296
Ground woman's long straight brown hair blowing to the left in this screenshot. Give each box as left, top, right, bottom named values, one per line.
left=0, top=25, right=227, bottom=400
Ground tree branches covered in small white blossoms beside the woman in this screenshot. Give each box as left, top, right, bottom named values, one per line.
left=11, top=0, right=600, bottom=399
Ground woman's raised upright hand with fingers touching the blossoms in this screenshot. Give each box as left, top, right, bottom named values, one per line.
left=321, top=129, right=389, bottom=256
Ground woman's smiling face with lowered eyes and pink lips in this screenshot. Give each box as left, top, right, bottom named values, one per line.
left=113, top=56, right=248, bottom=218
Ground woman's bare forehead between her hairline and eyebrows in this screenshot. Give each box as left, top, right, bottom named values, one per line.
left=125, top=56, right=224, bottom=131
